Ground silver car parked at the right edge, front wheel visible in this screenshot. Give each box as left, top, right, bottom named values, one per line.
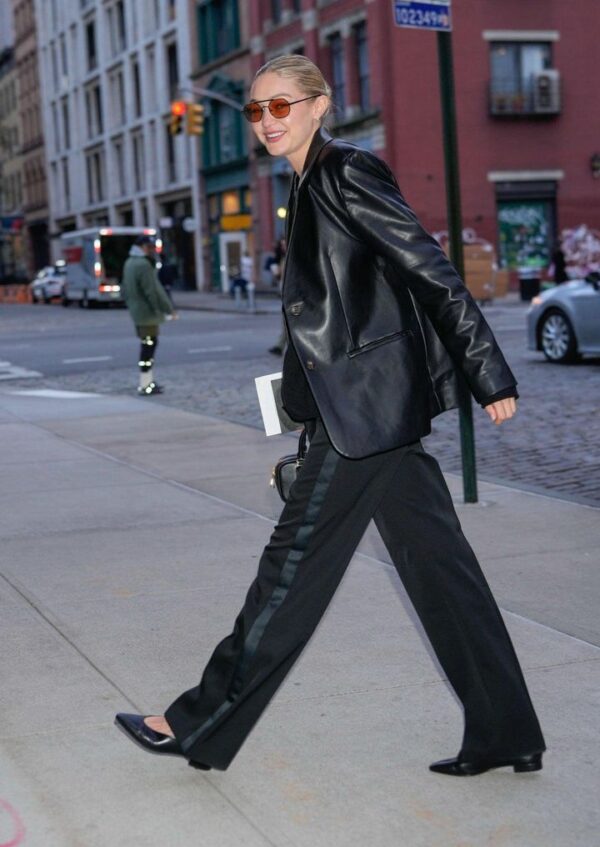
left=527, top=271, right=600, bottom=363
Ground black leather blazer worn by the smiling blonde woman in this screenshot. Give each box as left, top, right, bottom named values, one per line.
left=282, top=129, right=516, bottom=458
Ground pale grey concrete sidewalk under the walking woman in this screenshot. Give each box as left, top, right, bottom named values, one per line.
left=0, top=390, right=600, bottom=847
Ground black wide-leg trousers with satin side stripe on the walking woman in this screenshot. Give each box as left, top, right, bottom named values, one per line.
left=165, top=422, right=545, bottom=770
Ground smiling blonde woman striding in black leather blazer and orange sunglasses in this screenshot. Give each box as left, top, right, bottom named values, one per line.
left=117, top=55, right=545, bottom=776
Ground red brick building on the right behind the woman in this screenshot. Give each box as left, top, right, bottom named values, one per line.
left=249, top=0, right=600, bottom=284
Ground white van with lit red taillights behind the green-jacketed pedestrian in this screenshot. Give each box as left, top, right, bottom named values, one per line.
left=60, top=226, right=161, bottom=308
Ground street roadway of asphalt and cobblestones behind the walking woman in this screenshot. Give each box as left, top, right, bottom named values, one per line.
left=0, top=302, right=600, bottom=506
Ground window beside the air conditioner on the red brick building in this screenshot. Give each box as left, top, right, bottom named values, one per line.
left=490, top=41, right=552, bottom=114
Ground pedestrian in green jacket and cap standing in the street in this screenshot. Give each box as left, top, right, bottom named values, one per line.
left=121, top=235, right=177, bottom=395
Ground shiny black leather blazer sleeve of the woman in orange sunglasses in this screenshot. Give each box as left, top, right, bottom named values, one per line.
left=339, top=149, right=517, bottom=403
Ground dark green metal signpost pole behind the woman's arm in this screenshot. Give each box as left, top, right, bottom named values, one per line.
left=437, top=32, right=477, bottom=503
